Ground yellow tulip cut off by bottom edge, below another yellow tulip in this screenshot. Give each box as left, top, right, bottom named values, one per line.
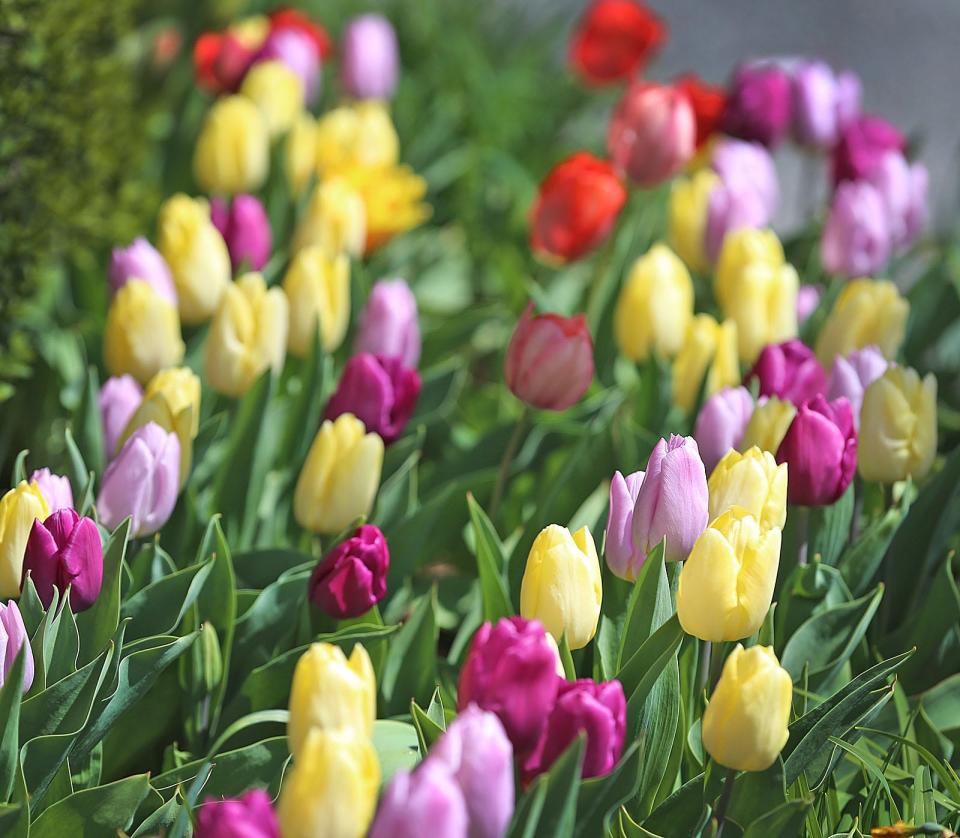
left=277, top=729, right=380, bottom=838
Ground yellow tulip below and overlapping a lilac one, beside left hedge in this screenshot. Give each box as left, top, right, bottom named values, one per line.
left=103, top=279, right=186, bottom=383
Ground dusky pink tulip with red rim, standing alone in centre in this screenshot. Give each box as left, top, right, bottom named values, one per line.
left=504, top=303, right=593, bottom=410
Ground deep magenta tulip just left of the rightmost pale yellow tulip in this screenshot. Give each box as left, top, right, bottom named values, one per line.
left=777, top=396, right=857, bottom=506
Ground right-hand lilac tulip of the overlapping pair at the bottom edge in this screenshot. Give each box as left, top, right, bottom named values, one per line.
left=428, top=704, right=515, bottom=838
